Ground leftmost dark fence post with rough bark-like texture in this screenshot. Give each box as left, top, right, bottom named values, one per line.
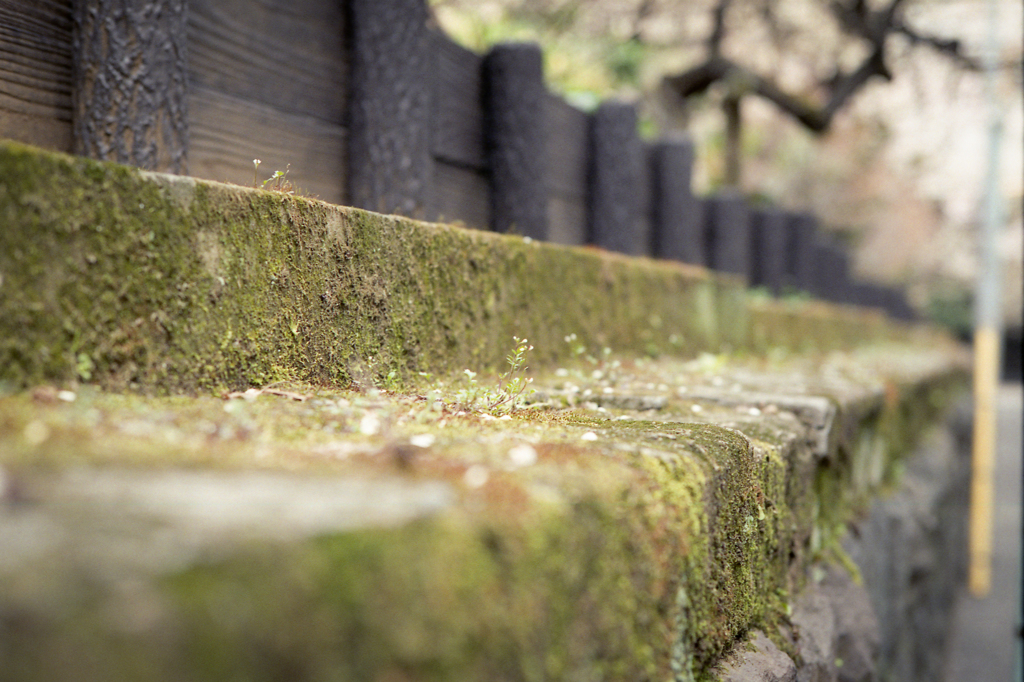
left=72, top=0, right=188, bottom=173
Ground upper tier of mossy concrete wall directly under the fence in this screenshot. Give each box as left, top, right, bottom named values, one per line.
left=0, top=142, right=921, bottom=392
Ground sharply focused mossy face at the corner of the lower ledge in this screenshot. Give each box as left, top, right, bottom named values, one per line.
left=548, top=411, right=811, bottom=672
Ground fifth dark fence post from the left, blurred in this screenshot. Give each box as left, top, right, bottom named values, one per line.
left=651, top=139, right=705, bottom=264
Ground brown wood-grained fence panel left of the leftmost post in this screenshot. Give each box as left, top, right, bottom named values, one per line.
left=0, top=0, right=73, bottom=152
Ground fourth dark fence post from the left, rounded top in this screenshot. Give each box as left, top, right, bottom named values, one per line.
left=587, top=101, right=649, bottom=256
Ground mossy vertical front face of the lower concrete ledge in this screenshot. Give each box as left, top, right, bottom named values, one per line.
left=0, top=342, right=964, bottom=679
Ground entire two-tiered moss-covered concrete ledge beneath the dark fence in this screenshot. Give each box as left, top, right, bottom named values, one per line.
left=0, top=143, right=967, bottom=681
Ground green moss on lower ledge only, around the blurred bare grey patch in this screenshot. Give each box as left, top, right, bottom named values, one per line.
left=0, top=346, right=970, bottom=680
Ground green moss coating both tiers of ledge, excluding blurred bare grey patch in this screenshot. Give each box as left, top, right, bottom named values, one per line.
left=0, top=139, right=964, bottom=680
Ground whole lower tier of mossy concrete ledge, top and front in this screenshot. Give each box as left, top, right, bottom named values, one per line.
left=0, top=345, right=965, bottom=680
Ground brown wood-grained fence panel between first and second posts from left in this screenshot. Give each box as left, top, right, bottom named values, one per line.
left=188, top=0, right=349, bottom=203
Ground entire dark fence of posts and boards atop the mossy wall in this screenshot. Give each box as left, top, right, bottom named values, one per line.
left=0, top=0, right=880, bottom=307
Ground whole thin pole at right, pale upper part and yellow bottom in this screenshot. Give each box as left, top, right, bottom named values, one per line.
left=968, top=0, right=1002, bottom=597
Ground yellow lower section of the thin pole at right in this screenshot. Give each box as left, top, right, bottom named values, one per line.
left=968, top=327, right=999, bottom=597
